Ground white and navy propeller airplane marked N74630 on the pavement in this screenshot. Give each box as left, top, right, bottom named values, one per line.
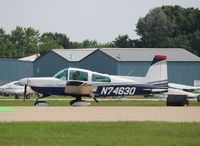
left=20, top=55, right=168, bottom=106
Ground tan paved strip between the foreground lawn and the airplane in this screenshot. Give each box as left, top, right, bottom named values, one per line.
left=0, top=107, right=200, bottom=122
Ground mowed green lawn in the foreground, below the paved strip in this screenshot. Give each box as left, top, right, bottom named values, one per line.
left=0, top=122, right=200, bottom=146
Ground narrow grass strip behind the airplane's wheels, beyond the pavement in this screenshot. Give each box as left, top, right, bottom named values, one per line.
left=0, top=96, right=200, bottom=106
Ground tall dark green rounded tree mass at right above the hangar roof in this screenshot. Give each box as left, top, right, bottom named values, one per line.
left=135, top=6, right=200, bottom=55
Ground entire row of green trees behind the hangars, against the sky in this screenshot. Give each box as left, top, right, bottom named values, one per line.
left=0, top=6, right=200, bottom=58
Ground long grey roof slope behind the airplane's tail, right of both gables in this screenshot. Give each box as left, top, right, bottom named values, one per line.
left=101, top=48, right=200, bottom=61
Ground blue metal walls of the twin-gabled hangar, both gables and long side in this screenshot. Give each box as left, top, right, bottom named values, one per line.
left=34, top=50, right=200, bottom=85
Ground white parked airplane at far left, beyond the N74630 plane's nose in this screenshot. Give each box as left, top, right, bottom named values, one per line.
left=0, top=81, right=33, bottom=99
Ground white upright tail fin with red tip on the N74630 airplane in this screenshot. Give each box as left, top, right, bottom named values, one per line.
left=145, top=55, right=168, bottom=86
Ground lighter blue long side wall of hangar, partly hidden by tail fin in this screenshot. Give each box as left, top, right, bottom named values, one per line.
left=118, top=62, right=200, bottom=85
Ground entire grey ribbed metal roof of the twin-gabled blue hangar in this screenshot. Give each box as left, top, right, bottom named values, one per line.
left=53, top=48, right=200, bottom=62
